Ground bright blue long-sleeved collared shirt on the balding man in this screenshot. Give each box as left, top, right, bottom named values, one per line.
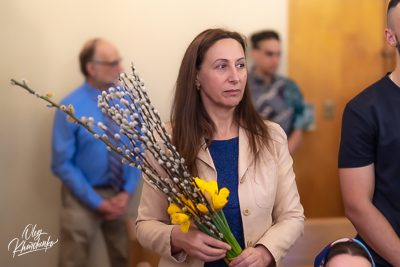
left=51, top=82, right=141, bottom=210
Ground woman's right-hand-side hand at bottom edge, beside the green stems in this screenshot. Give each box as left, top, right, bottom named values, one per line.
left=229, top=245, right=275, bottom=267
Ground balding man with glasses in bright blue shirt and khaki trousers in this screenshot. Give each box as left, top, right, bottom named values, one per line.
left=51, top=39, right=140, bottom=267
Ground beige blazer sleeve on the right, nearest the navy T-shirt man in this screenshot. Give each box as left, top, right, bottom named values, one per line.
left=257, top=123, right=305, bottom=263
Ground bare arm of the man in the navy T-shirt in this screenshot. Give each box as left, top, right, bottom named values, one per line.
left=339, top=164, right=400, bottom=266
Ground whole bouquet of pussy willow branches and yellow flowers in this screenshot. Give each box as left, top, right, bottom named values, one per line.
left=11, top=66, right=242, bottom=264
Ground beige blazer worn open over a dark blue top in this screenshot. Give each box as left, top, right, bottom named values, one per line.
left=136, top=122, right=305, bottom=267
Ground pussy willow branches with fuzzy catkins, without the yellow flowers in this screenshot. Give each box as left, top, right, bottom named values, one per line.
left=11, top=74, right=223, bottom=238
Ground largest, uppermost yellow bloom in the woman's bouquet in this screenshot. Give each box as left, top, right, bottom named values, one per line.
left=195, top=177, right=229, bottom=213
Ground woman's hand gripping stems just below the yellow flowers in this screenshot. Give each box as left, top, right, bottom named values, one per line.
left=171, top=226, right=231, bottom=262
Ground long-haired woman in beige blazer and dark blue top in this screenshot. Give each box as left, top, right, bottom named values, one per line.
left=136, top=29, right=304, bottom=267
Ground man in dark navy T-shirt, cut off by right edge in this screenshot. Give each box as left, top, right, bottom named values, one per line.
left=339, top=0, right=400, bottom=266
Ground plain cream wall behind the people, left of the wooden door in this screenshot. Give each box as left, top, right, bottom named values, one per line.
left=0, top=0, right=287, bottom=267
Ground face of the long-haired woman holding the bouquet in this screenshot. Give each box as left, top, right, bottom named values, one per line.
left=196, top=39, right=247, bottom=111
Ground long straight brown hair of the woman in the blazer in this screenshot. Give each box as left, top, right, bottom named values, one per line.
left=170, top=29, right=269, bottom=175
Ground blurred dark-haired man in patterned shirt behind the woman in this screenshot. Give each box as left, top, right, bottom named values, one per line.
left=248, top=31, right=314, bottom=154
